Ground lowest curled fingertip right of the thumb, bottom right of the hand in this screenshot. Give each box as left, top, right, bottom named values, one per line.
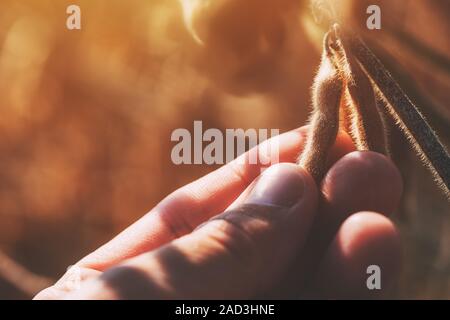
left=314, top=212, right=401, bottom=299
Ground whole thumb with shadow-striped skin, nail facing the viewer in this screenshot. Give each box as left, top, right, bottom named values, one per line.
left=64, top=164, right=317, bottom=299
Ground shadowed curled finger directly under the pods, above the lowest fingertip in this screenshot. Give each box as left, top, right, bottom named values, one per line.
left=273, top=151, right=402, bottom=298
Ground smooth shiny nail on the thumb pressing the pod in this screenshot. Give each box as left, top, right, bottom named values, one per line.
left=244, top=164, right=305, bottom=208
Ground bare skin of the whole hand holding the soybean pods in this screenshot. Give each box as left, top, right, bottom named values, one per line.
left=35, top=127, right=402, bottom=299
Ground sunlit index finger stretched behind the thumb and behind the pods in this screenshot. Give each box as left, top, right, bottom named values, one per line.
left=78, top=127, right=354, bottom=270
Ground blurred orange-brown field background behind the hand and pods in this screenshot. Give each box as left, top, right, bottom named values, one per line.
left=0, top=0, right=450, bottom=299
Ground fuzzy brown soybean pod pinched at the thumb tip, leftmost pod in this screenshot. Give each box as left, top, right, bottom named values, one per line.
left=298, top=34, right=343, bottom=184
